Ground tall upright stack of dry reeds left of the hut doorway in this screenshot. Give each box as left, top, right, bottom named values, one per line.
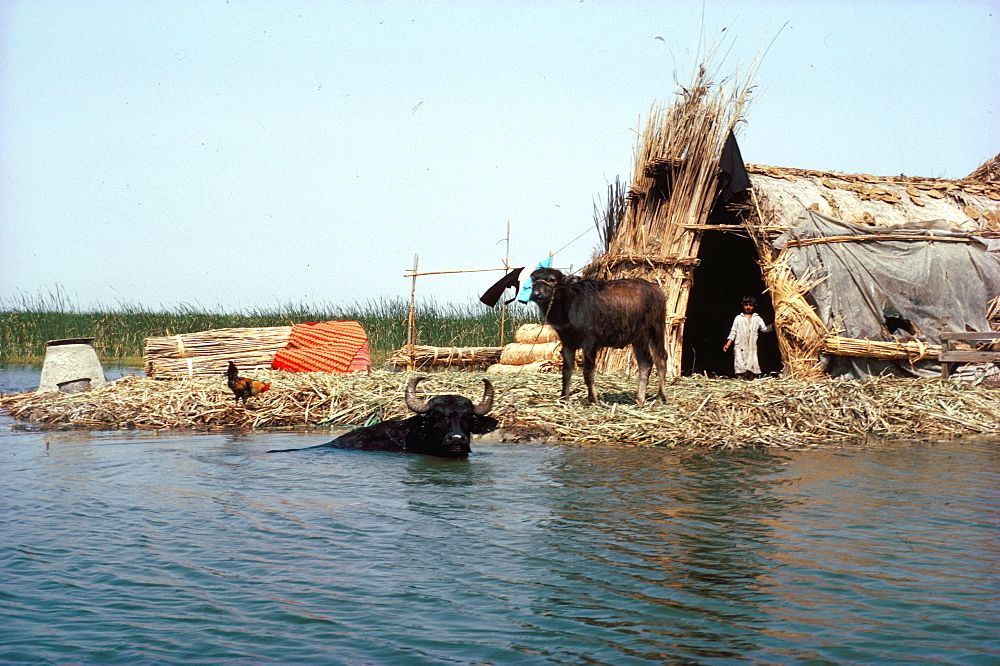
left=583, top=65, right=750, bottom=376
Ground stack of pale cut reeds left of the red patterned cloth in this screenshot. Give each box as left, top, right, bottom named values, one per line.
left=144, top=326, right=292, bottom=378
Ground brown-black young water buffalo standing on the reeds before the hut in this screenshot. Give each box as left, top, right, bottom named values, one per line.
left=531, top=268, right=667, bottom=405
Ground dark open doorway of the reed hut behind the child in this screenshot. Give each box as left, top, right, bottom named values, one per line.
left=681, top=231, right=782, bottom=377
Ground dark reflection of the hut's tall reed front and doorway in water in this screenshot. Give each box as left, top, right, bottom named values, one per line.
left=532, top=449, right=796, bottom=659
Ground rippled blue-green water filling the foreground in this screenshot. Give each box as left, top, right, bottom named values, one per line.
left=0, top=366, right=1000, bottom=665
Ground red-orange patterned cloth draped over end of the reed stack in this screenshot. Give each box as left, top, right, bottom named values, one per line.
left=271, top=321, right=369, bottom=372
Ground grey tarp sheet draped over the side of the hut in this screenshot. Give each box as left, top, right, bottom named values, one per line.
left=774, top=210, right=1000, bottom=378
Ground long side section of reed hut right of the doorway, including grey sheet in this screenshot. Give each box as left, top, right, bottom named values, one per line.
left=740, top=158, right=1000, bottom=377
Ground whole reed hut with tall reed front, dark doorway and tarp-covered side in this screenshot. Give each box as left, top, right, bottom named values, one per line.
left=583, top=68, right=1000, bottom=379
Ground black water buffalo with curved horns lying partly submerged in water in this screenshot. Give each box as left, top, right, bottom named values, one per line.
left=268, top=377, right=498, bottom=458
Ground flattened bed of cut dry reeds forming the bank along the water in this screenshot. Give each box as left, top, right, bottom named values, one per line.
left=0, top=371, right=1000, bottom=448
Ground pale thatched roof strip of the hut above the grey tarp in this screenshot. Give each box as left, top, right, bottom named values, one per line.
left=747, top=164, right=1000, bottom=237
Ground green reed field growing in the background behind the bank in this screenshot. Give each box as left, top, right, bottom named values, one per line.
left=0, top=292, right=539, bottom=366
